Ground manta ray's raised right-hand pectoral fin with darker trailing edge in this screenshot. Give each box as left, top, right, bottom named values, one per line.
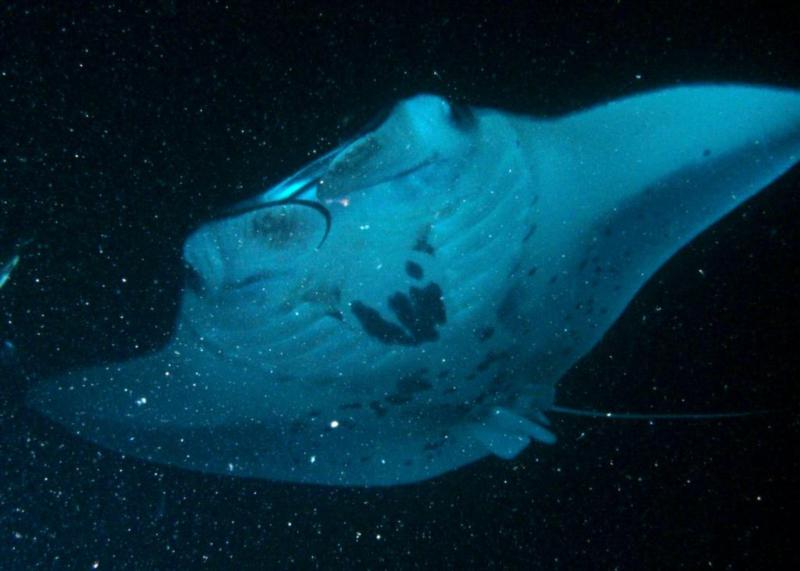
left=522, top=86, right=800, bottom=346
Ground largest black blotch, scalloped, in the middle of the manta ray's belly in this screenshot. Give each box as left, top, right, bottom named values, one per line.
left=351, top=282, right=447, bottom=345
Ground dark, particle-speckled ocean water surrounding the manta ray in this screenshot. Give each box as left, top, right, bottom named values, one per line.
left=0, top=0, right=800, bottom=570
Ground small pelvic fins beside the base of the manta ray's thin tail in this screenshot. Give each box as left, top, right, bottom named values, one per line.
left=469, top=407, right=556, bottom=460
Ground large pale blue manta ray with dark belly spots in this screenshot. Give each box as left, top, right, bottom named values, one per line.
left=29, top=85, right=800, bottom=486
